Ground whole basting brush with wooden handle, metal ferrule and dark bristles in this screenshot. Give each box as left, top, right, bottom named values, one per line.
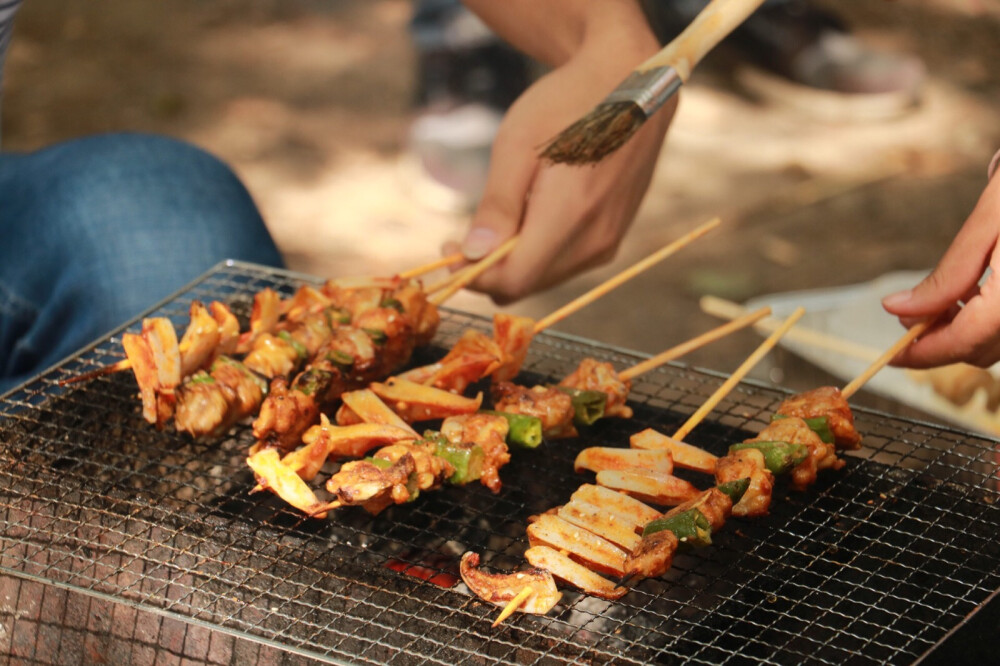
left=542, top=0, right=764, bottom=164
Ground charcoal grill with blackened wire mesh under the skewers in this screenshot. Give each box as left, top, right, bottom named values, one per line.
left=0, top=262, right=1000, bottom=664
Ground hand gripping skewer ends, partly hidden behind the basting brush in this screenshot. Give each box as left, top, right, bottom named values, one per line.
left=445, top=25, right=676, bottom=304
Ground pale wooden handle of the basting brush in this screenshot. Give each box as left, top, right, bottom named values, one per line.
left=637, top=0, right=764, bottom=82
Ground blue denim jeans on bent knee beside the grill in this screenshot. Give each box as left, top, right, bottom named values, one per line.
left=0, top=134, right=282, bottom=394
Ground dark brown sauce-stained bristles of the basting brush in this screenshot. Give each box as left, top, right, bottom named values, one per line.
left=542, top=102, right=646, bottom=165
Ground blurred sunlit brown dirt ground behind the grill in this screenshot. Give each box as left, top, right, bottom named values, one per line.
left=3, top=0, right=1000, bottom=418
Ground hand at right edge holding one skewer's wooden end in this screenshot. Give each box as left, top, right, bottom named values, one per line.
left=882, top=178, right=1000, bottom=368
